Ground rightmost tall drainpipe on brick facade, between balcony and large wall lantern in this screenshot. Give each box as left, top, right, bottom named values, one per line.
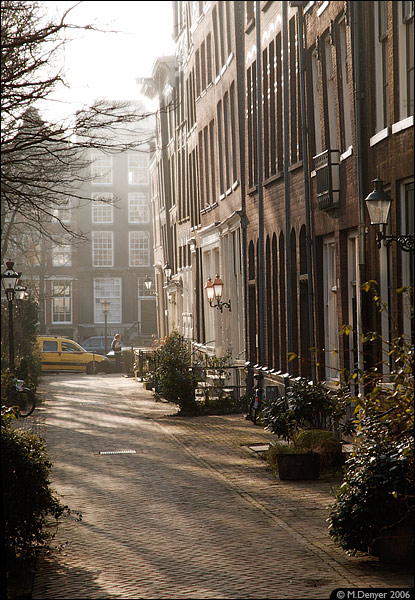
left=350, top=2, right=366, bottom=404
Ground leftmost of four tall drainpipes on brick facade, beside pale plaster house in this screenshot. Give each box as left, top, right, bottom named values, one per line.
left=255, top=2, right=264, bottom=366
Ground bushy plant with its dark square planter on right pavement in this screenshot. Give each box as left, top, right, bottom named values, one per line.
left=262, top=378, right=348, bottom=480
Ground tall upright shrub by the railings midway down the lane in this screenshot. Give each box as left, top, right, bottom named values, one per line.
left=155, top=331, right=197, bottom=414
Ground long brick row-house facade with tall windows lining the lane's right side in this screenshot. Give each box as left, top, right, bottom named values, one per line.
left=142, top=2, right=414, bottom=394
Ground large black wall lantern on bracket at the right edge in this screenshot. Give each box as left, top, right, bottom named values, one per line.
left=365, top=177, right=414, bottom=252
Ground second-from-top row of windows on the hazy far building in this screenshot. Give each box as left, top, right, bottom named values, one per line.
left=54, top=192, right=150, bottom=223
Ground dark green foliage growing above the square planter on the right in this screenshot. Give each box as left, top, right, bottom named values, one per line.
left=262, top=378, right=349, bottom=440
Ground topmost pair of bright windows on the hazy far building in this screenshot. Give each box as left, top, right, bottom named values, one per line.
left=91, top=153, right=148, bottom=185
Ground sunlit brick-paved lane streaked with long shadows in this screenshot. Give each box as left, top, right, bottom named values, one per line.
left=13, top=375, right=413, bottom=600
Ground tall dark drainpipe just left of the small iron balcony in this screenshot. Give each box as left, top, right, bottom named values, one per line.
left=298, top=2, right=316, bottom=383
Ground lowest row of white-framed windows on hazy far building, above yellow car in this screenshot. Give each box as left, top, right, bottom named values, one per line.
left=50, top=276, right=154, bottom=324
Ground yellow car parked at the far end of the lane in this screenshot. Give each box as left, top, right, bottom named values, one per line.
left=37, top=335, right=111, bottom=375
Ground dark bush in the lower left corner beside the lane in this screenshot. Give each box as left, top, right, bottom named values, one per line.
left=1, top=416, right=68, bottom=566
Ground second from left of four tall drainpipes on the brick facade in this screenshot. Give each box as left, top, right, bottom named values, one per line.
left=282, top=2, right=292, bottom=372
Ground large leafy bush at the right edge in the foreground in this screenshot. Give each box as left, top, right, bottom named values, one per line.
left=328, top=282, right=414, bottom=554
